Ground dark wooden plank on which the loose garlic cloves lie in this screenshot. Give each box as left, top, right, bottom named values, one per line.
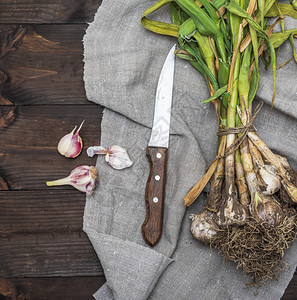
left=0, top=104, right=102, bottom=190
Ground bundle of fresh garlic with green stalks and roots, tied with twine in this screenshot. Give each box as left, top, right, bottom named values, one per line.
left=141, top=0, right=297, bottom=284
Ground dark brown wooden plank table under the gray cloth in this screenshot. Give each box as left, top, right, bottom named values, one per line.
left=0, top=0, right=297, bottom=300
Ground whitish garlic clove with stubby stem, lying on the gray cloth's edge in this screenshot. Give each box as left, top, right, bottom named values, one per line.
left=87, top=145, right=133, bottom=170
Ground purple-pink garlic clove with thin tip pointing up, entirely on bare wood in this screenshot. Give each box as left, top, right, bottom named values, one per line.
left=58, top=121, right=85, bottom=158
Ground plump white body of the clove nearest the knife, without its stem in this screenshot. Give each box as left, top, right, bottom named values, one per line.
left=105, top=145, right=133, bottom=170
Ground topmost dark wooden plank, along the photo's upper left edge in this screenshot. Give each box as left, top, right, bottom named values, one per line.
left=0, top=0, right=102, bottom=23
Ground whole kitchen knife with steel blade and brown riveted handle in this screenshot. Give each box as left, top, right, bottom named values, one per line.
left=142, top=45, right=176, bottom=247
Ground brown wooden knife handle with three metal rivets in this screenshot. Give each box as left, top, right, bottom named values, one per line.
left=142, top=147, right=168, bottom=247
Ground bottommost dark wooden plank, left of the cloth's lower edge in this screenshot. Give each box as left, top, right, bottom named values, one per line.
left=0, top=276, right=105, bottom=300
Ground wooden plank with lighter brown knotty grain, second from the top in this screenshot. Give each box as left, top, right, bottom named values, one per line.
left=0, top=25, right=93, bottom=105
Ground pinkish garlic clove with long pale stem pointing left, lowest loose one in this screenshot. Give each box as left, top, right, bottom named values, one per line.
left=46, top=165, right=98, bottom=196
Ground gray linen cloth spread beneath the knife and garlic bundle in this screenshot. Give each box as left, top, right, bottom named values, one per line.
left=83, top=0, right=297, bottom=300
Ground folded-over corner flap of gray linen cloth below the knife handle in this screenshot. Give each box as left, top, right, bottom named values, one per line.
left=84, top=228, right=173, bottom=300
